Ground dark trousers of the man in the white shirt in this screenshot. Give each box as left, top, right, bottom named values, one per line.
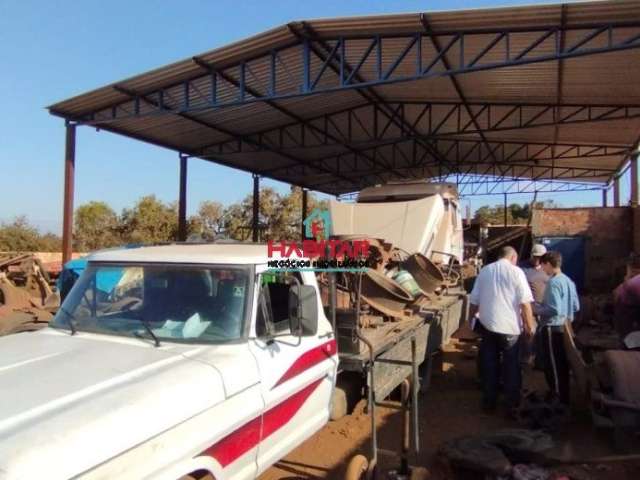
left=479, top=325, right=522, bottom=408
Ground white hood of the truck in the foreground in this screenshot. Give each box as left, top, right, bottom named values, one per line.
left=0, top=329, right=225, bottom=480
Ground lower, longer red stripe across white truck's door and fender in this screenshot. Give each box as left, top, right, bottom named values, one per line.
left=201, top=378, right=323, bottom=468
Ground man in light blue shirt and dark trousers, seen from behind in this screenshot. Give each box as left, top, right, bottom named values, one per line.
left=534, top=252, right=580, bottom=404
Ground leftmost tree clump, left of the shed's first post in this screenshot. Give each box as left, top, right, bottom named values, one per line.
left=0, top=216, right=62, bottom=252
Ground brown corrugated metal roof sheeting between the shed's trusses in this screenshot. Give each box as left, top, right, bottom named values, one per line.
left=50, top=0, right=640, bottom=193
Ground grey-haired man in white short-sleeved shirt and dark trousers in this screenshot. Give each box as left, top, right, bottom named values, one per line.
left=469, top=247, right=534, bottom=411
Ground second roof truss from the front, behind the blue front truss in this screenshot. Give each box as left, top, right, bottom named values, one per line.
left=196, top=101, right=640, bottom=153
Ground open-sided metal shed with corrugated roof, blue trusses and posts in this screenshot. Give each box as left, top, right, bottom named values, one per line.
left=48, top=0, right=640, bottom=262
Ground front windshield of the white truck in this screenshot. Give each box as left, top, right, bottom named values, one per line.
left=52, top=264, right=250, bottom=343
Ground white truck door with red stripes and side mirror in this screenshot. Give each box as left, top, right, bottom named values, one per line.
left=249, top=271, right=338, bottom=474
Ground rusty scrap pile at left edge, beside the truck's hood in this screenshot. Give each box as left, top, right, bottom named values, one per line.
left=0, top=254, right=60, bottom=335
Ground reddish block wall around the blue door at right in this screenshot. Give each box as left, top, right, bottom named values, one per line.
left=531, top=207, right=640, bottom=293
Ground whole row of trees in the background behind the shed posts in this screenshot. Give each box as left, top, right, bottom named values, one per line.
left=0, top=187, right=336, bottom=252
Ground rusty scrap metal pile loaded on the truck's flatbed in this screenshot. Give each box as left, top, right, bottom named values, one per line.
left=320, top=236, right=461, bottom=328
